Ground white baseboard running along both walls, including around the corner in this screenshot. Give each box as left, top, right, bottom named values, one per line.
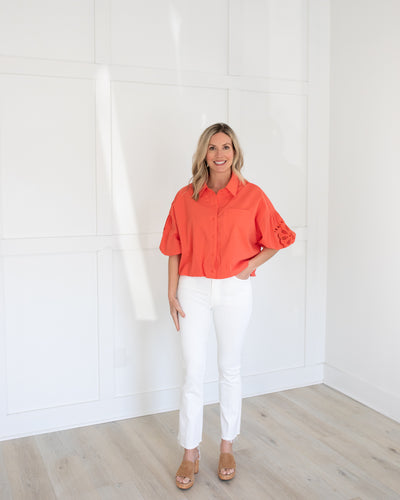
left=0, top=363, right=400, bottom=440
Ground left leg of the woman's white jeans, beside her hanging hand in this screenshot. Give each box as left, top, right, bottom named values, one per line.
left=177, top=276, right=212, bottom=449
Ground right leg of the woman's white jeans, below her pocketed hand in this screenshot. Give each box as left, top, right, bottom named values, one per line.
left=213, top=277, right=253, bottom=441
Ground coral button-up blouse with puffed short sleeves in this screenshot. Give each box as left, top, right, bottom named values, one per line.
left=160, top=174, right=296, bottom=279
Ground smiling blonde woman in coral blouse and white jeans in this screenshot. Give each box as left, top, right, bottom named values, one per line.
left=160, top=123, right=295, bottom=489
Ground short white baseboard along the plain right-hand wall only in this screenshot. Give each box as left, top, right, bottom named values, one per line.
left=324, top=363, right=400, bottom=422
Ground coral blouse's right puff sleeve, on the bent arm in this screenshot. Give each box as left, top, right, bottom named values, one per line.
left=256, top=193, right=296, bottom=250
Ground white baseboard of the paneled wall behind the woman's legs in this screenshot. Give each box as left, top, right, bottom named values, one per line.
left=0, top=364, right=323, bottom=441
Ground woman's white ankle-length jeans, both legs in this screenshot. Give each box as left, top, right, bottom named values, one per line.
left=177, top=276, right=252, bottom=449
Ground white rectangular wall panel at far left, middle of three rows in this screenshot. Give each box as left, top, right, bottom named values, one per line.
left=0, top=75, right=96, bottom=238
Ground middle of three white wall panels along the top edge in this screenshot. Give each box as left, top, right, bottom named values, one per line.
left=110, top=0, right=229, bottom=75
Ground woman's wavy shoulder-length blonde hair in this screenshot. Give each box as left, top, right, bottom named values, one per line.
left=191, top=123, right=245, bottom=201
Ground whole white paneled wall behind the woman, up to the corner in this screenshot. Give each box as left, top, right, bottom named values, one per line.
left=0, top=0, right=329, bottom=439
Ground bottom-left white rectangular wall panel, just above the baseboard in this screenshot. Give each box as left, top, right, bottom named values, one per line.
left=4, top=253, right=99, bottom=414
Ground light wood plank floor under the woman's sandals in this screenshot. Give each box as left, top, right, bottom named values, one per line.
left=0, top=384, right=400, bottom=500
